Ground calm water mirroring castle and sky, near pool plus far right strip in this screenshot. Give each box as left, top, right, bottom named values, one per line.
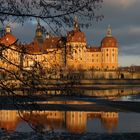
left=0, top=89, right=140, bottom=134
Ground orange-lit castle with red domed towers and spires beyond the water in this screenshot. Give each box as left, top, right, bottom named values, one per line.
left=0, top=18, right=118, bottom=71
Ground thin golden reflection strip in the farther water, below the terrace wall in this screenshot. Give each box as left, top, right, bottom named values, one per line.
left=46, top=85, right=140, bottom=97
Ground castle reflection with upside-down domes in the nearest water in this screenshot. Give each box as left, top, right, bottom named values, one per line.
left=0, top=102, right=119, bottom=133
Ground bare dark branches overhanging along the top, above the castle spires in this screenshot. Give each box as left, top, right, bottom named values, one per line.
left=0, top=0, right=103, bottom=31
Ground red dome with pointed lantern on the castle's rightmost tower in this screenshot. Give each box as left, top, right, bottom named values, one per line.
left=101, top=25, right=118, bottom=48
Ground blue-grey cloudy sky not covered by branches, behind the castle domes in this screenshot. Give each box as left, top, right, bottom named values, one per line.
left=12, top=0, right=140, bottom=66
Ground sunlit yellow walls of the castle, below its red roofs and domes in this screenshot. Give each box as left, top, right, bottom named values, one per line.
left=0, top=43, right=118, bottom=70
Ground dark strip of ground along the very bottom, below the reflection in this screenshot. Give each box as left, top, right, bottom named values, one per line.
left=0, top=132, right=140, bottom=140
